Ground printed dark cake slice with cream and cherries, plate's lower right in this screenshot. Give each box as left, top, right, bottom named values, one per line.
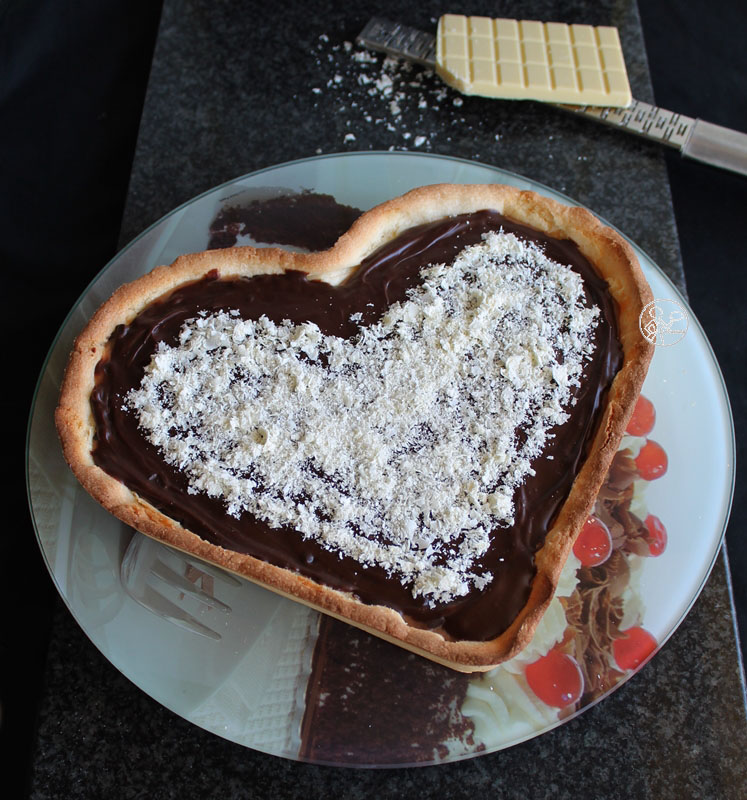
left=299, top=397, right=667, bottom=764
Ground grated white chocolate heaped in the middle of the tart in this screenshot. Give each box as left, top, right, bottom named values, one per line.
left=125, top=232, right=599, bottom=604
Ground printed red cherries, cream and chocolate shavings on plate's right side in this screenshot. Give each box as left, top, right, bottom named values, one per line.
left=462, top=396, right=667, bottom=748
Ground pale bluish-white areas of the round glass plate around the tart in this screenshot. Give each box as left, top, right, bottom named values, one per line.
left=28, top=153, right=734, bottom=766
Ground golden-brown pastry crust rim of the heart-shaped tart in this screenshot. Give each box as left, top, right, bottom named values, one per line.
left=56, top=184, right=653, bottom=672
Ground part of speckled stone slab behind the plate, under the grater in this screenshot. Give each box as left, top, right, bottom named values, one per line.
left=120, top=2, right=682, bottom=294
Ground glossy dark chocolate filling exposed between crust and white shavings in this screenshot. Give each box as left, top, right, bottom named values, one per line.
left=91, top=211, right=622, bottom=641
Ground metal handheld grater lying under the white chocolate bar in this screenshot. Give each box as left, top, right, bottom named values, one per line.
left=356, top=17, right=747, bottom=175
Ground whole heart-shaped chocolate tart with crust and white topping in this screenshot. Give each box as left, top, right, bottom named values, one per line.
left=57, top=185, right=652, bottom=671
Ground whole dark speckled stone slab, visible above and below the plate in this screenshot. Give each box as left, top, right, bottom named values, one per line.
left=32, top=0, right=747, bottom=800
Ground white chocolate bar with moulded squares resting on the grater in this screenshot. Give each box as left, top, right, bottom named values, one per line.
left=436, top=14, right=632, bottom=106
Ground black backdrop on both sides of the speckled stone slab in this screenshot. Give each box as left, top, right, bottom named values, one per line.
left=0, top=0, right=747, bottom=797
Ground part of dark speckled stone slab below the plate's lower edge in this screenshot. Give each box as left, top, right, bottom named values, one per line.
left=27, top=559, right=747, bottom=800
